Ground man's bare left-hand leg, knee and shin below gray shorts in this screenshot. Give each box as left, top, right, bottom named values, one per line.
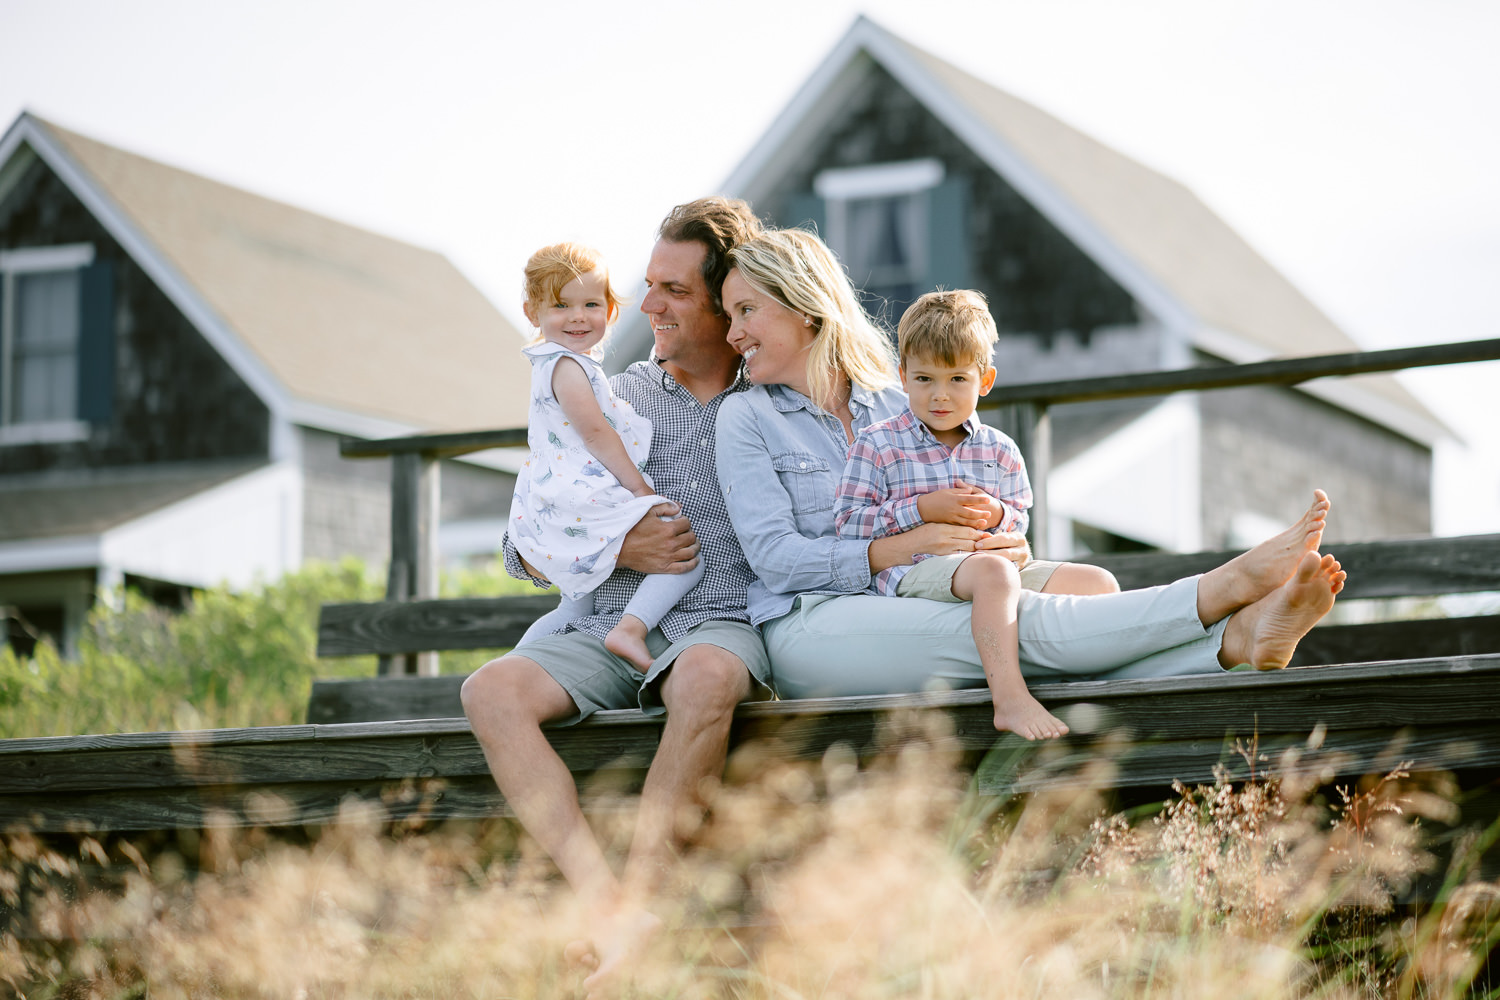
left=462, top=654, right=620, bottom=907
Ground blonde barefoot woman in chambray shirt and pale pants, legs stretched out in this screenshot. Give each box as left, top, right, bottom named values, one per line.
left=717, top=229, right=1344, bottom=697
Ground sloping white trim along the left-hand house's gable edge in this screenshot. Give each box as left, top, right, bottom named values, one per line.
left=0, top=111, right=290, bottom=417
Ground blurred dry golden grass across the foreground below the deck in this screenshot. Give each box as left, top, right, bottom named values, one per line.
left=0, top=724, right=1500, bottom=1000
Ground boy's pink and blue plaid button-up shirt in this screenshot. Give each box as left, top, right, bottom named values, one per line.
left=834, top=408, right=1032, bottom=595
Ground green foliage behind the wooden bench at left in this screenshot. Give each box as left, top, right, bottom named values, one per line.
left=0, top=559, right=531, bottom=738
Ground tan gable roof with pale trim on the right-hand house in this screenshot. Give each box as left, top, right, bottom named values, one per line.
left=725, top=16, right=1451, bottom=444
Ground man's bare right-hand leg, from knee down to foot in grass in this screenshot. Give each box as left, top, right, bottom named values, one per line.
left=584, top=643, right=750, bottom=994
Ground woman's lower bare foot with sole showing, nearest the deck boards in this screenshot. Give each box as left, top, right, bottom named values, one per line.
left=1220, top=552, right=1346, bottom=670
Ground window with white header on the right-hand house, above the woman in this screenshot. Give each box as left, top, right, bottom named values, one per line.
left=813, top=159, right=944, bottom=321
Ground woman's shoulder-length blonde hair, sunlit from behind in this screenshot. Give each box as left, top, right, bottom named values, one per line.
left=729, top=229, right=896, bottom=409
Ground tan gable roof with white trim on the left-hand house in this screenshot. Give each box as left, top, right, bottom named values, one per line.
left=0, top=112, right=530, bottom=436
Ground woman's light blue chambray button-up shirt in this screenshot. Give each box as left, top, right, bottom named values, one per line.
left=719, top=385, right=906, bottom=625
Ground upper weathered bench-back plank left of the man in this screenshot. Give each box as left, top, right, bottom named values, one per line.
left=318, top=594, right=558, bottom=657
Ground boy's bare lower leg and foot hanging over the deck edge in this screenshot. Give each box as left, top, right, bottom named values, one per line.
left=953, top=552, right=1068, bottom=739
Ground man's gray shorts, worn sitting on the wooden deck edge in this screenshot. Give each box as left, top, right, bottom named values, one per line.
left=513, top=621, right=771, bottom=726
